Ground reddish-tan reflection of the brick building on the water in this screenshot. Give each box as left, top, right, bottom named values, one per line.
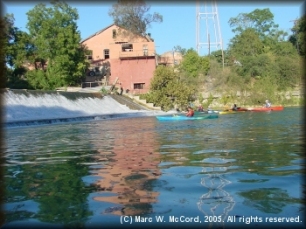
left=87, top=119, right=161, bottom=215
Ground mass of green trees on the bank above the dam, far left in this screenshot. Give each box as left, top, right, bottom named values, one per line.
left=4, top=1, right=89, bottom=90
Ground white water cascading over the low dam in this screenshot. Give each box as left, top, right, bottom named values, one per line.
left=3, top=90, right=163, bottom=126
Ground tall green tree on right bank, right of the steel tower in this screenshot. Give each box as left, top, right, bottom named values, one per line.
left=229, top=9, right=300, bottom=90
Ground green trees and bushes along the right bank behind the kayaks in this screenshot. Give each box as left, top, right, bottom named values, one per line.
left=142, top=9, right=306, bottom=110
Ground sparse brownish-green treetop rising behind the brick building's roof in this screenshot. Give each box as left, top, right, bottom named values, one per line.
left=109, top=0, right=163, bottom=35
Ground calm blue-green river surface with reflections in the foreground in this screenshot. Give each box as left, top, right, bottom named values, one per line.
left=3, top=108, right=305, bottom=228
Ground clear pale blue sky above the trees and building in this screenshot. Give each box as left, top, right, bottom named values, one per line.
left=2, top=0, right=305, bottom=55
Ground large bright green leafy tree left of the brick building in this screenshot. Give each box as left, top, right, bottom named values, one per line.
left=27, top=1, right=88, bottom=89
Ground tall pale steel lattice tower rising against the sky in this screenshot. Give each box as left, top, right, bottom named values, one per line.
left=196, top=0, right=224, bottom=67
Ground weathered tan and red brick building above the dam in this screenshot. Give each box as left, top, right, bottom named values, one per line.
left=81, top=24, right=156, bottom=94
